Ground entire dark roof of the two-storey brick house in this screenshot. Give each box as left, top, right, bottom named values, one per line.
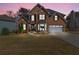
left=17, top=3, right=65, bottom=20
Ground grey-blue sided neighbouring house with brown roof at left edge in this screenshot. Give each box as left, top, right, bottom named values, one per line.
left=0, top=15, right=16, bottom=33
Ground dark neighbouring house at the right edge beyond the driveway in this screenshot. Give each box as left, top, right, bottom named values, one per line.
left=66, top=10, right=79, bottom=31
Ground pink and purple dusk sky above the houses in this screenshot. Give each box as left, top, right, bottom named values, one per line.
left=0, top=3, right=79, bottom=14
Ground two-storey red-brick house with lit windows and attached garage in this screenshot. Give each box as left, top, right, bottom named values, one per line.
left=17, top=4, right=65, bottom=32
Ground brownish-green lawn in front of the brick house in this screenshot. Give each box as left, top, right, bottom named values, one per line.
left=0, top=34, right=79, bottom=55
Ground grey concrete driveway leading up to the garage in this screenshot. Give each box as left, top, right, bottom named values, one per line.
left=49, top=32, right=79, bottom=48
